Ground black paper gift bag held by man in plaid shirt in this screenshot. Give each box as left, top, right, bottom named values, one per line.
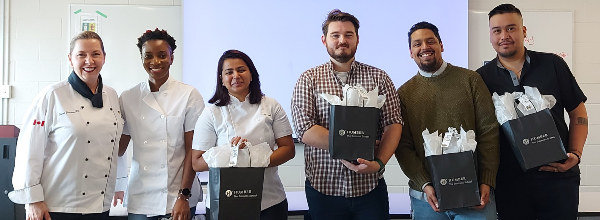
left=329, top=105, right=379, bottom=161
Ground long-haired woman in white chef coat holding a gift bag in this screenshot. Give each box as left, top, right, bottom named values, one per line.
left=193, top=50, right=296, bottom=220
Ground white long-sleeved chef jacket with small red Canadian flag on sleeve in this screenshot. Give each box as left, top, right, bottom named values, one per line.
left=8, top=80, right=123, bottom=213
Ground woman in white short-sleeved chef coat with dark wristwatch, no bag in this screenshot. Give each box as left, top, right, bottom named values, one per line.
left=119, top=28, right=204, bottom=220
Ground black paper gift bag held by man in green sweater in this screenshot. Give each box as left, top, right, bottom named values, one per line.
left=427, top=151, right=480, bottom=210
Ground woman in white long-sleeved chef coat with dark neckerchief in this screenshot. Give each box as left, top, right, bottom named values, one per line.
left=8, top=31, right=123, bottom=220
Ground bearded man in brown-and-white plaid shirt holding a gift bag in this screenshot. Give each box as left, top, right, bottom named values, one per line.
left=292, top=9, right=402, bottom=220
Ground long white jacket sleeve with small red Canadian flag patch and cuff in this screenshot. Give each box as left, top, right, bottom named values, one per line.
left=8, top=90, right=54, bottom=204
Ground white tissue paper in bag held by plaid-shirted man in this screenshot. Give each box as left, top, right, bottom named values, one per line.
left=319, top=84, right=386, bottom=108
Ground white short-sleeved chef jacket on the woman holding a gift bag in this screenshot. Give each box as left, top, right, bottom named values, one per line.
left=192, top=95, right=292, bottom=210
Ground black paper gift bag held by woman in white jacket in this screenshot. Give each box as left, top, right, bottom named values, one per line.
left=208, top=167, right=265, bottom=220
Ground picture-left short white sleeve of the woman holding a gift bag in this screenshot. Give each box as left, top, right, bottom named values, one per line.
left=192, top=108, right=217, bottom=151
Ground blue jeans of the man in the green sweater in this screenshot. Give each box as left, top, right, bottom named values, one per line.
left=410, top=192, right=498, bottom=220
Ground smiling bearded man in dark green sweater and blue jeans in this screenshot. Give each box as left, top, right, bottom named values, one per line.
left=396, top=22, right=499, bottom=220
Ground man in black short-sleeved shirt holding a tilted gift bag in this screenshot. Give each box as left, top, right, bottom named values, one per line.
left=477, top=4, right=588, bottom=220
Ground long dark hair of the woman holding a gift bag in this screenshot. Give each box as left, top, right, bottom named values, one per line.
left=208, top=50, right=264, bottom=106
